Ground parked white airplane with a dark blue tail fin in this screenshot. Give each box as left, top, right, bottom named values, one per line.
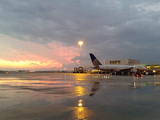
left=89, top=53, right=147, bottom=72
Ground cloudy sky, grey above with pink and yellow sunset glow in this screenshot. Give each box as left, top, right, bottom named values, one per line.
left=0, top=0, right=160, bottom=70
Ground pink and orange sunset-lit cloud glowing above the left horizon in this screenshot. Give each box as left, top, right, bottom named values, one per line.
left=0, top=34, right=79, bottom=68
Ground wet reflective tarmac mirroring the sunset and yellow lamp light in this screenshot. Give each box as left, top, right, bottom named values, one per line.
left=0, top=73, right=160, bottom=120
